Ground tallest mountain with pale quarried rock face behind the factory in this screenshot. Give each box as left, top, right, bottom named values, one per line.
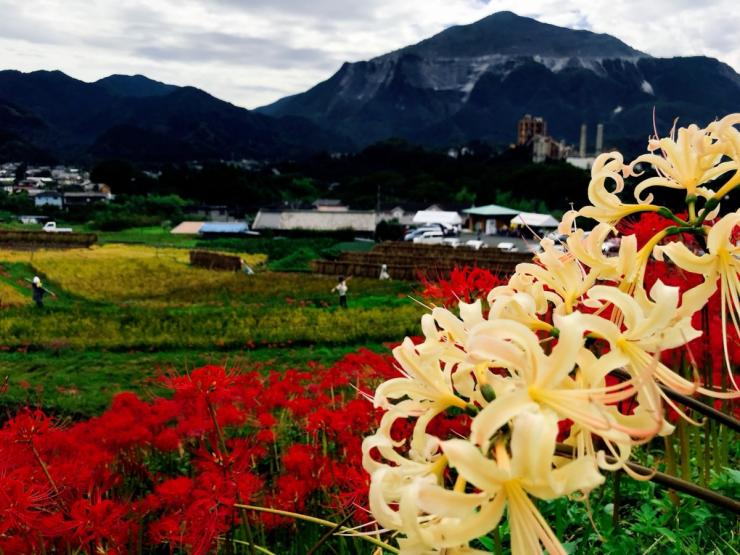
left=257, top=12, right=740, bottom=150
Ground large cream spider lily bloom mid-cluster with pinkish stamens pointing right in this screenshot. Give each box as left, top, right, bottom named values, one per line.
left=466, top=314, right=661, bottom=467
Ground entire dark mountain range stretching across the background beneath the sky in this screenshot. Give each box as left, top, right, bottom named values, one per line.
left=0, top=12, right=740, bottom=163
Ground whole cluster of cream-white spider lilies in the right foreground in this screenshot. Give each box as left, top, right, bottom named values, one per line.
left=363, top=114, right=740, bottom=555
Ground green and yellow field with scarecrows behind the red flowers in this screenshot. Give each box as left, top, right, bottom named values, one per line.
left=0, top=241, right=424, bottom=416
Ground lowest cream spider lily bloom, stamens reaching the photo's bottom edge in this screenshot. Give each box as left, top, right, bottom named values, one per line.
left=400, top=411, right=604, bottom=555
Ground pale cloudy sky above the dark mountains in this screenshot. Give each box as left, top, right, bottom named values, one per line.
left=0, top=0, right=740, bottom=108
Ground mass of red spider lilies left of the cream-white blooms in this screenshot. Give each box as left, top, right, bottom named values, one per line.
left=0, top=350, right=397, bottom=555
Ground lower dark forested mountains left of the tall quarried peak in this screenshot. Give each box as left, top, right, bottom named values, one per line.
left=0, top=71, right=350, bottom=163
